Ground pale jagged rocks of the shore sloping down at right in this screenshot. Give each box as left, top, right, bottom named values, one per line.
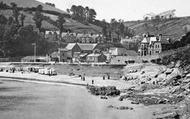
left=119, top=62, right=190, bottom=119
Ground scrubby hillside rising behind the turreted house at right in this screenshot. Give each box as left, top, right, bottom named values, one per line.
left=125, top=17, right=190, bottom=41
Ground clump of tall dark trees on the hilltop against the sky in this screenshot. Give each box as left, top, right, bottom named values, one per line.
left=67, top=5, right=97, bottom=24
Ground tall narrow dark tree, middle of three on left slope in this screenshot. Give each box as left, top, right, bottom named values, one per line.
left=33, top=5, right=44, bottom=32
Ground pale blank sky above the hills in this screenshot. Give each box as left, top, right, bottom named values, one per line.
left=38, top=0, right=190, bottom=22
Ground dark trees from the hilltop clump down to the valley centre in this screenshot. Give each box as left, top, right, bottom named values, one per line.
left=67, top=5, right=134, bottom=39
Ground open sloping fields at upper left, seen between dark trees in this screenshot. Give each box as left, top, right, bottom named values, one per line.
left=0, top=0, right=102, bottom=33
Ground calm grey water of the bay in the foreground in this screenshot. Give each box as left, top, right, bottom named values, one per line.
left=0, top=79, right=166, bottom=119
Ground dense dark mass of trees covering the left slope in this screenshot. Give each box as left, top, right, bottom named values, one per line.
left=0, top=3, right=63, bottom=57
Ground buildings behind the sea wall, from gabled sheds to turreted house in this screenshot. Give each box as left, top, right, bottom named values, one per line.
left=47, top=32, right=171, bottom=62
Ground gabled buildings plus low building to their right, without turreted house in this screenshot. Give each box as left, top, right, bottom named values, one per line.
left=51, top=43, right=138, bottom=62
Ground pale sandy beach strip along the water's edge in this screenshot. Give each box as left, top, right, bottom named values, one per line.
left=0, top=72, right=132, bottom=90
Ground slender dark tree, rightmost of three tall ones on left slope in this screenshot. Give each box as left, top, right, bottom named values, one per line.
left=56, top=14, right=66, bottom=38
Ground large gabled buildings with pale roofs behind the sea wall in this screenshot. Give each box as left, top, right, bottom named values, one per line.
left=51, top=43, right=107, bottom=62
